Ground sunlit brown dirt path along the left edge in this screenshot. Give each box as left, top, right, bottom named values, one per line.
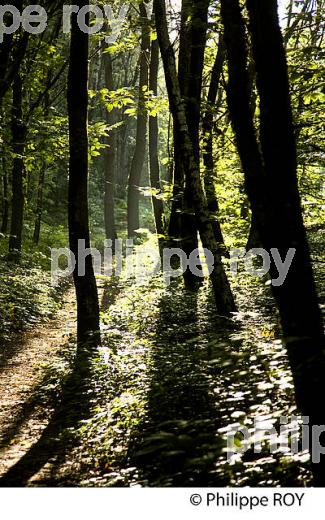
left=0, top=288, right=76, bottom=476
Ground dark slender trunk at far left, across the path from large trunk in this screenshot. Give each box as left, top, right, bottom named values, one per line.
left=9, top=74, right=27, bottom=261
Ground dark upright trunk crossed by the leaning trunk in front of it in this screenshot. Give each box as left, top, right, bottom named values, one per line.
left=169, top=0, right=208, bottom=290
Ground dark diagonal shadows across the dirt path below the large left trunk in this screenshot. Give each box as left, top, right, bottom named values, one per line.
left=0, top=285, right=118, bottom=487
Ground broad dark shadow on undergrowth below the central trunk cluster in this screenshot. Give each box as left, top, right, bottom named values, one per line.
left=130, top=294, right=228, bottom=486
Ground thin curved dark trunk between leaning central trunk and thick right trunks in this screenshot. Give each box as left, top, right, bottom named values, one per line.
left=202, top=35, right=229, bottom=256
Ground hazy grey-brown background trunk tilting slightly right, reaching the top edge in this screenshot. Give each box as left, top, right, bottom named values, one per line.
left=128, top=2, right=150, bottom=238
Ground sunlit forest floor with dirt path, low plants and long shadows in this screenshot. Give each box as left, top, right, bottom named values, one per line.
left=0, top=233, right=324, bottom=487
